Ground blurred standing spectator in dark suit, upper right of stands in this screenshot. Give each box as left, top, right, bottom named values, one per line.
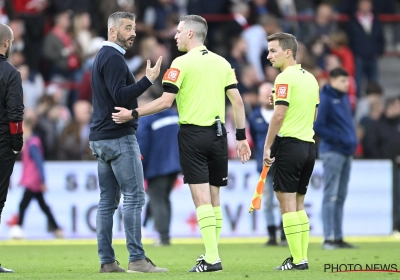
left=347, top=0, right=385, bottom=97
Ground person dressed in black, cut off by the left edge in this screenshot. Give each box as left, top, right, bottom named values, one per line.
left=0, top=23, right=24, bottom=273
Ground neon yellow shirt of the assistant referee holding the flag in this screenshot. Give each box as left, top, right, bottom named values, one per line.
left=274, top=64, right=319, bottom=142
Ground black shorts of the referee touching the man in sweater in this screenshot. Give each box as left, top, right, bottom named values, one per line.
left=178, top=125, right=228, bottom=186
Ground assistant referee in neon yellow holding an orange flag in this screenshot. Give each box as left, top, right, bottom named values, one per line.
left=264, top=33, right=319, bottom=270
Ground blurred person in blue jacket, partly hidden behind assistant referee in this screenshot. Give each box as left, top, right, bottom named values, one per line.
left=249, top=83, right=287, bottom=246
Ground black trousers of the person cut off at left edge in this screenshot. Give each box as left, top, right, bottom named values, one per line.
left=0, top=147, right=17, bottom=222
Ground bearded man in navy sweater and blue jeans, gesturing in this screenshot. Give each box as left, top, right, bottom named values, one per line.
left=89, top=12, right=168, bottom=272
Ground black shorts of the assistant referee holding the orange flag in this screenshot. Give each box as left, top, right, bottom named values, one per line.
left=271, top=136, right=316, bottom=194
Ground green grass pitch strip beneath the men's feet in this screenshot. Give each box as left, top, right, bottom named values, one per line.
left=0, top=237, right=400, bottom=280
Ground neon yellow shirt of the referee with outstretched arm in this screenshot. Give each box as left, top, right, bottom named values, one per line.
left=162, top=46, right=237, bottom=126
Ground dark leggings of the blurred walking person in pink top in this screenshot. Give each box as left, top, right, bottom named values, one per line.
left=18, top=189, right=59, bottom=231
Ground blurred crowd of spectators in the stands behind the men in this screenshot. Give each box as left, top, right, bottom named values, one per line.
left=0, top=0, right=400, bottom=162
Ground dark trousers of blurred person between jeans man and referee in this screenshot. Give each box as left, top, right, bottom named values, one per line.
left=147, top=173, right=178, bottom=243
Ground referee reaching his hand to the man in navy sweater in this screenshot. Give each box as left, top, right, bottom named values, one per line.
left=113, top=15, right=251, bottom=272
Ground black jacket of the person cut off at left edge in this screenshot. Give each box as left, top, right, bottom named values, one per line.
left=0, top=55, right=24, bottom=155
